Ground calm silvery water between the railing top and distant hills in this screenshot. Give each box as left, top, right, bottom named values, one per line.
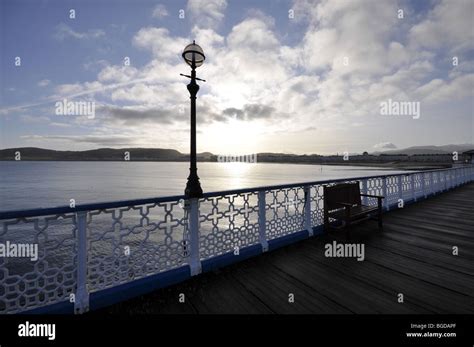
left=0, top=161, right=408, bottom=210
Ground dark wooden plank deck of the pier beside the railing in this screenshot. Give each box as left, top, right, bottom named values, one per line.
left=96, top=183, right=474, bottom=314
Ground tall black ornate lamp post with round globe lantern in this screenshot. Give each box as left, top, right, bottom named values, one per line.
left=181, top=41, right=206, bottom=198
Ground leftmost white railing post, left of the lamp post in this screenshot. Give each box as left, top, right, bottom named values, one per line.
left=74, top=211, right=89, bottom=314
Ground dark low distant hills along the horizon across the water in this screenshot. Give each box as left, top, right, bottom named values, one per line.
left=0, top=144, right=474, bottom=167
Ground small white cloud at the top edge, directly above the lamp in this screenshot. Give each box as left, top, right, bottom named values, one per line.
left=186, top=0, right=227, bottom=28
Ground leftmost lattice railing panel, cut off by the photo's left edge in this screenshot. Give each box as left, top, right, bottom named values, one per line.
left=0, top=214, right=77, bottom=313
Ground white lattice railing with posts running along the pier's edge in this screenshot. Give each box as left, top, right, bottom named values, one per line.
left=0, top=166, right=474, bottom=313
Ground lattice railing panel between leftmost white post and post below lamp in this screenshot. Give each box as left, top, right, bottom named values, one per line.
left=87, top=201, right=187, bottom=292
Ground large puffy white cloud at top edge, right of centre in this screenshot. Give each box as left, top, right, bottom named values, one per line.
left=296, top=0, right=402, bottom=77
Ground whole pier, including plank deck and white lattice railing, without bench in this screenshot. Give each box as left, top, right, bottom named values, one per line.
left=0, top=166, right=474, bottom=314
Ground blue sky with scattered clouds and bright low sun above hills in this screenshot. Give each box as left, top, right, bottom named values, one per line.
left=0, top=0, right=474, bottom=155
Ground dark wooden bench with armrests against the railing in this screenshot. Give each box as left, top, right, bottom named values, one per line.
left=323, top=182, right=385, bottom=238
